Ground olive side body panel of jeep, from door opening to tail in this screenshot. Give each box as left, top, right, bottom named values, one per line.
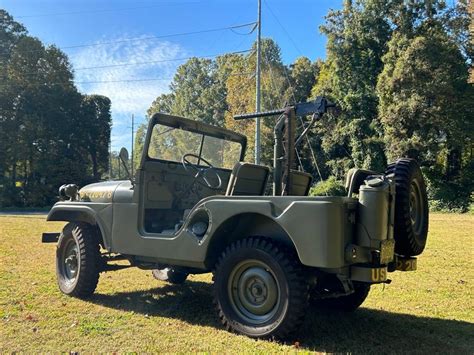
left=108, top=196, right=356, bottom=269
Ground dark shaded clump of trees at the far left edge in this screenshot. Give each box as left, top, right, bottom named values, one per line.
left=0, top=9, right=111, bottom=207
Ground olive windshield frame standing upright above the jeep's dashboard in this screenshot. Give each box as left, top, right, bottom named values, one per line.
left=141, top=113, right=247, bottom=170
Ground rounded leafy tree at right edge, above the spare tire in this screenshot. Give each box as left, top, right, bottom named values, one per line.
left=377, top=24, right=474, bottom=211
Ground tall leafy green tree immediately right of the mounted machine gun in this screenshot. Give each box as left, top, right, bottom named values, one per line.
left=312, top=0, right=392, bottom=178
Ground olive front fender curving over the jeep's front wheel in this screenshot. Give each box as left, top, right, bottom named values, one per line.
left=46, top=202, right=113, bottom=251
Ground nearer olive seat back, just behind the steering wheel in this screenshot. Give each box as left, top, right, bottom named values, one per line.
left=225, top=162, right=270, bottom=196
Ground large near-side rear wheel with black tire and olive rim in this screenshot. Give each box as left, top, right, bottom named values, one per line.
left=214, top=238, right=309, bottom=339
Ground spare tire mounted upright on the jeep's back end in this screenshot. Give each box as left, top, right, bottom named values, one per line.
left=385, top=158, right=428, bottom=256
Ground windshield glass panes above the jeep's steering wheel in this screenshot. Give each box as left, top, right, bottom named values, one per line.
left=148, top=124, right=242, bottom=169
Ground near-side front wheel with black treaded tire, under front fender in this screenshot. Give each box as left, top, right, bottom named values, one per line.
left=56, top=223, right=100, bottom=298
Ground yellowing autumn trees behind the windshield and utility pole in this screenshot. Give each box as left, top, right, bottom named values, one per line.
left=144, top=39, right=292, bottom=164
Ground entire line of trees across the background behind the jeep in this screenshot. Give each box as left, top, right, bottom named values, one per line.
left=0, top=0, right=474, bottom=211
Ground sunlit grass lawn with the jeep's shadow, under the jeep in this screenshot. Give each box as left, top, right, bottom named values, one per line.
left=0, top=214, right=474, bottom=354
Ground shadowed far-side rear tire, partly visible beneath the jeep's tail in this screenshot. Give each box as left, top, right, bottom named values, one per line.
left=312, top=281, right=370, bottom=312
